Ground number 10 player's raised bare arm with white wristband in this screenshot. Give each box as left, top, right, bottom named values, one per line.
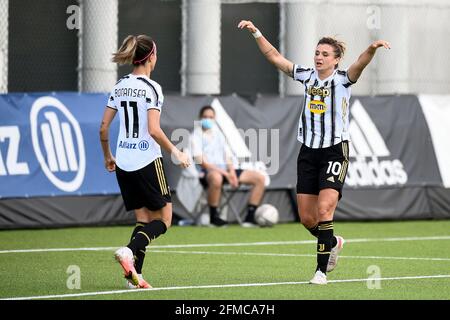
left=238, top=20, right=294, bottom=77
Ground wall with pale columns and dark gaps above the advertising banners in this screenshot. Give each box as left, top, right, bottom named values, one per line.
left=5, top=0, right=450, bottom=97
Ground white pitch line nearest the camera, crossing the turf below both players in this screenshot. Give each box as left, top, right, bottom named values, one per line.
left=0, top=274, right=450, bottom=300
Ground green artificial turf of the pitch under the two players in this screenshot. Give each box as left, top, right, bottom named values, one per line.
left=0, top=220, right=450, bottom=300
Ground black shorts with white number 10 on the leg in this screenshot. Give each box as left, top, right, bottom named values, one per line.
left=297, top=141, right=348, bottom=199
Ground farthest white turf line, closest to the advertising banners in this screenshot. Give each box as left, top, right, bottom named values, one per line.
left=0, top=236, right=450, bottom=254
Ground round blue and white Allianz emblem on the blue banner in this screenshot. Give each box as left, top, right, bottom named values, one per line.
left=30, top=97, right=86, bottom=192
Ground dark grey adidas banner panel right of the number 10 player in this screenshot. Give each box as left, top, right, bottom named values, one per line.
left=346, top=96, right=442, bottom=189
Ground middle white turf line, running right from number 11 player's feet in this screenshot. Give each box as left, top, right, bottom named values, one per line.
left=149, top=250, right=450, bottom=261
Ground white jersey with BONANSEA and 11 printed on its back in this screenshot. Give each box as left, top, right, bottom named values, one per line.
left=107, top=74, right=164, bottom=171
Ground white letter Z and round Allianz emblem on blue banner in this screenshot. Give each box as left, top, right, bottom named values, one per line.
left=0, top=97, right=86, bottom=192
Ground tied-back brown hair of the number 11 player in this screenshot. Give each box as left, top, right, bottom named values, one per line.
left=112, top=35, right=156, bottom=66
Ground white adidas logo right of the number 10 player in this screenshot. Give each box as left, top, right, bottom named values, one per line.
left=345, top=100, right=408, bottom=187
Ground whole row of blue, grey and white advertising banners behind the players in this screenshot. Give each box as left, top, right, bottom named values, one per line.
left=0, top=93, right=450, bottom=228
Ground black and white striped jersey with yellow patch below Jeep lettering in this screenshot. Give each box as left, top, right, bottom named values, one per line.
left=293, top=64, right=354, bottom=149
